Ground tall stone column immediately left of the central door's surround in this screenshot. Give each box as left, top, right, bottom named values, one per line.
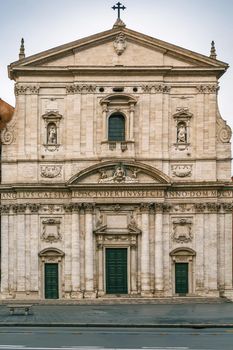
left=84, top=203, right=96, bottom=298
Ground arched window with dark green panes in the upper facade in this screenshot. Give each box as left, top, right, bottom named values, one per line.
left=108, top=113, right=125, bottom=141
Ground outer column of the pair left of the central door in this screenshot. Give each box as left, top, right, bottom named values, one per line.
left=71, top=203, right=83, bottom=298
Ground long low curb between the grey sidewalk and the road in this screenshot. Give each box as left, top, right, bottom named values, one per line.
left=0, top=322, right=233, bottom=329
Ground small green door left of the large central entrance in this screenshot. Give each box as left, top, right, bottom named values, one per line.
left=45, top=264, right=58, bottom=299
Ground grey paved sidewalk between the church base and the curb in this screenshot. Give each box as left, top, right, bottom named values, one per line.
left=0, top=303, right=233, bottom=327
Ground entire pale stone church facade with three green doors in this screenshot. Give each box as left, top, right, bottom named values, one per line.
left=0, top=20, right=233, bottom=299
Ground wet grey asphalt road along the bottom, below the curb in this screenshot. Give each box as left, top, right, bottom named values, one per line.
left=0, top=327, right=233, bottom=350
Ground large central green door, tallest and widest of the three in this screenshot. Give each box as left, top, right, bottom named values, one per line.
left=106, top=248, right=128, bottom=294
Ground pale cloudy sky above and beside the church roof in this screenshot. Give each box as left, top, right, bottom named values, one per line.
left=0, top=0, right=233, bottom=129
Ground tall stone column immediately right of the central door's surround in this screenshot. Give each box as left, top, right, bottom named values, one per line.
left=140, top=203, right=151, bottom=296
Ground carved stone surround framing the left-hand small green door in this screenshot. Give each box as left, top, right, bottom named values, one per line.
left=38, top=247, right=65, bottom=299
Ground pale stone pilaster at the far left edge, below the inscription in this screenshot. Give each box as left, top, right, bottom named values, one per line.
left=1, top=212, right=9, bottom=294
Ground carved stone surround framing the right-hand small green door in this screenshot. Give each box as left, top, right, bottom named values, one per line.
left=170, top=247, right=196, bottom=295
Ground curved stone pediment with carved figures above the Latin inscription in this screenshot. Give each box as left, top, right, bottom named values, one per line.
left=68, top=161, right=171, bottom=186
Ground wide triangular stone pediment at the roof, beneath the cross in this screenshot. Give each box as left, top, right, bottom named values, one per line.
left=9, top=27, right=228, bottom=77
